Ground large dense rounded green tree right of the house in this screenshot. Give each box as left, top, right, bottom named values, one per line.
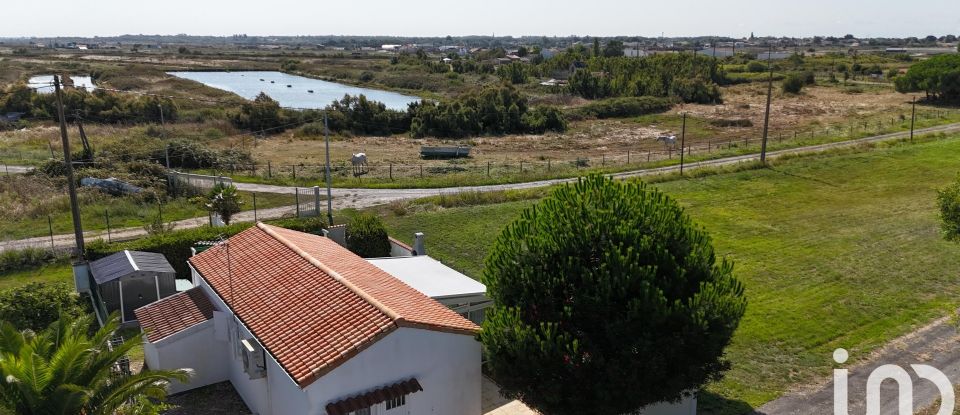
left=480, top=176, right=746, bottom=415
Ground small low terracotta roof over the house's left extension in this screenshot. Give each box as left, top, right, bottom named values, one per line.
left=133, top=288, right=213, bottom=342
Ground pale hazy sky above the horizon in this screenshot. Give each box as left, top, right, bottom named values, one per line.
left=0, top=0, right=960, bottom=37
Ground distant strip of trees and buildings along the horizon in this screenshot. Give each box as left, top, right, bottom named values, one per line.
left=7, top=33, right=957, bottom=59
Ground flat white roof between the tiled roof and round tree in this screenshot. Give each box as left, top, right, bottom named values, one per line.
left=367, top=255, right=487, bottom=299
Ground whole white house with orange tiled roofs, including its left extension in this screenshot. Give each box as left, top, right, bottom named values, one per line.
left=136, top=224, right=481, bottom=415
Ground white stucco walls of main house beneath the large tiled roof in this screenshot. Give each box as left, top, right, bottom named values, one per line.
left=185, top=266, right=481, bottom=415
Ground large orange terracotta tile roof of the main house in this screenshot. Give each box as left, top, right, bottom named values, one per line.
left=190, top=224, right=479, bottom=387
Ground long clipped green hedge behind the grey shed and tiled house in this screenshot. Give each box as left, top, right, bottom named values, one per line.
left=86, top=218, right=325, bottom=278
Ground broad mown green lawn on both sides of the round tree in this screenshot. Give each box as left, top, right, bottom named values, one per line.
left=383, top=136, right=960, bottom=414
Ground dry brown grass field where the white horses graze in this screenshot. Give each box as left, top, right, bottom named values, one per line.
left=244, top=84, right=940, bottom=168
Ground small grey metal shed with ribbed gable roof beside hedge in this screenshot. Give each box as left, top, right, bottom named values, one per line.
left=90, top=251, right=177, bottom=322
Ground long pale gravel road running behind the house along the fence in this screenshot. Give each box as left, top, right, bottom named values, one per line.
left=0, top=123, right=960, bottom=251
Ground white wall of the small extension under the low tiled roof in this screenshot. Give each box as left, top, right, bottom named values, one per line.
left=144, top=320, right=227, bottom=394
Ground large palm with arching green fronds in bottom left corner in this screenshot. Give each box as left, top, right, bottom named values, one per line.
left=0, top=315, right=188, bottom=415
